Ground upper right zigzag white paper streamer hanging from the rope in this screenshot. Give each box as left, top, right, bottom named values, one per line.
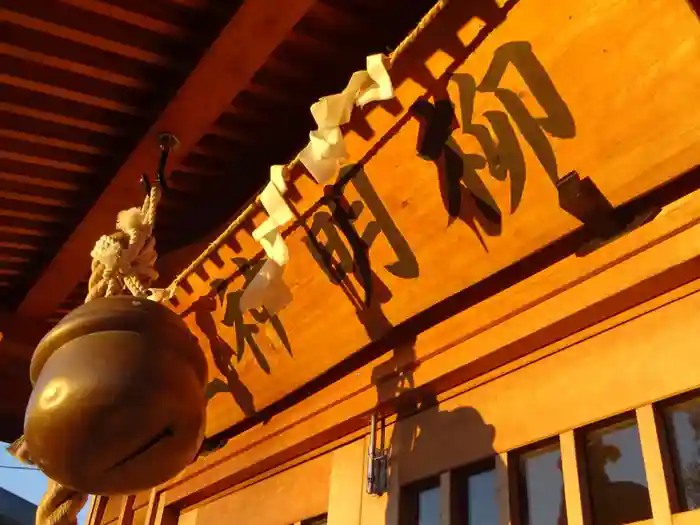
left=299, top=55, right=394, bottom=184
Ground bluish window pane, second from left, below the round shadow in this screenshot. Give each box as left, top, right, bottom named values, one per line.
left=453, top=461, right=499, bottom=525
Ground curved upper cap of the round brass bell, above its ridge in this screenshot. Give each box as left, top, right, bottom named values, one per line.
left=29, top=295, right=208, bottom=388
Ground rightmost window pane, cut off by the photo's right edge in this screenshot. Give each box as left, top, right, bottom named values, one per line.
left=664, top=398, right=700, bottom=510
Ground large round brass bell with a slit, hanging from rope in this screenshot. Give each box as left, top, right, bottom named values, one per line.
left=24, top=296, right=207, bottom=495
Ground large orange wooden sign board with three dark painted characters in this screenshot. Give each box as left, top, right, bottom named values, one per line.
left=171, top=0, right=700, bottom=435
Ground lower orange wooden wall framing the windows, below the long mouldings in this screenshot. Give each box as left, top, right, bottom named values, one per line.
left=95, top=270, right=700, bottom=525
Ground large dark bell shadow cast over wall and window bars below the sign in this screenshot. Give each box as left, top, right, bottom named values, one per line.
left=373, top=344, right=502, bottom=525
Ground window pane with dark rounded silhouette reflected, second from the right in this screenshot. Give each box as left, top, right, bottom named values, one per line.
left=586, top=418, right=651, bottom=525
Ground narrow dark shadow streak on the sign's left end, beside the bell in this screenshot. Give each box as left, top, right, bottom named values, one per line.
left=189, top=288, right=256, bottom=416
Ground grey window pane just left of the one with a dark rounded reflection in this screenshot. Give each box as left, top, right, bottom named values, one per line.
left=519, top=444, right=567, bottom=525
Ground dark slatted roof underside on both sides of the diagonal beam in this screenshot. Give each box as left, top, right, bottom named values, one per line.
left=0, top=0, right=433, bottom=440
